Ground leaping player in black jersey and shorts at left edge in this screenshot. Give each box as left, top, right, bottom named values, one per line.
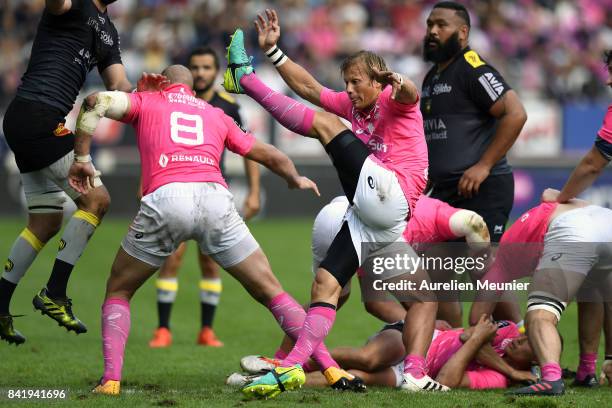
left=0, top=0, right=163, bottom=344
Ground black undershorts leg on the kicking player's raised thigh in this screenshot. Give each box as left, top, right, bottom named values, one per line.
left=325, top=130, right=370, bottom=204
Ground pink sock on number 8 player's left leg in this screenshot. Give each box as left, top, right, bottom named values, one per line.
left=102, top=298, right=130, bottom=383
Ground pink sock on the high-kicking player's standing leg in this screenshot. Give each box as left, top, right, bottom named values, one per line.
left=281, top=306, right=336, bottom=371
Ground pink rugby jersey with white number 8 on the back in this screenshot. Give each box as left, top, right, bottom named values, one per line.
left=122, top=84, right=255, bottom=195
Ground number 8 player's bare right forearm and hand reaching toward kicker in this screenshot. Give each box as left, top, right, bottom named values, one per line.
left=245, top=140, right=321, bottom=196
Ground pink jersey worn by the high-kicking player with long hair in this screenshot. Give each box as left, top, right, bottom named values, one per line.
left=320, top=86, right=429, bottom=213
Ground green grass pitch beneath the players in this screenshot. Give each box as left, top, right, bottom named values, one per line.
left=0, top=218, right=612, bottom=407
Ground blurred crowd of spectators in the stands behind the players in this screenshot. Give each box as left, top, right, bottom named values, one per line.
left=0, top=0, right=612, bottom=109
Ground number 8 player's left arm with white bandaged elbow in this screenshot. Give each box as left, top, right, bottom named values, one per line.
left=68, top=92, right=130, bottom=194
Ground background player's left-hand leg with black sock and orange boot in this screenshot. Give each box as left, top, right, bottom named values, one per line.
left=149, top=242, right=187, bottom=348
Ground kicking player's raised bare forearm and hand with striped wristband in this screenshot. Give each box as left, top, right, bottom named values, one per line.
left=255, top=9, right=323, bottom=107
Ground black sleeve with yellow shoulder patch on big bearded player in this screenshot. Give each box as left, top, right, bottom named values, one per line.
left=464, top=51, right=511, bottom=112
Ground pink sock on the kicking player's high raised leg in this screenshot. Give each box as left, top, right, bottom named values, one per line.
left=240, top=73, right=315, bottom=136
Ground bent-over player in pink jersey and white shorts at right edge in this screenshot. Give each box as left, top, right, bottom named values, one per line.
left=471, top=191, right=612, bottom=395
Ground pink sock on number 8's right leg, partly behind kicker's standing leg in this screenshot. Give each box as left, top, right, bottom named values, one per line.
left=268, top=292, right=339, bottom=371
